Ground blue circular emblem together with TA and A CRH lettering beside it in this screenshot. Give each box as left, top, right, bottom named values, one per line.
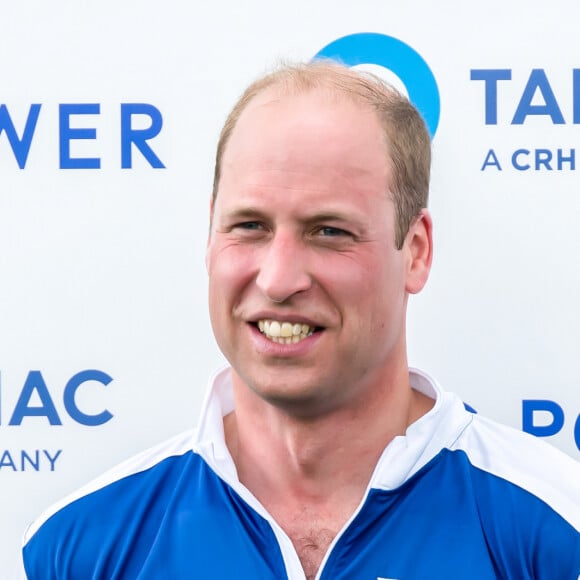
left=314, top=32, right=580, bottom=172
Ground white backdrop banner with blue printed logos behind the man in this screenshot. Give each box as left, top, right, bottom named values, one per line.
left=0, top=0, right=580, bottom=577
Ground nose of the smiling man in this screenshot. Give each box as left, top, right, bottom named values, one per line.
left=256, top=232, right=312, bottom=303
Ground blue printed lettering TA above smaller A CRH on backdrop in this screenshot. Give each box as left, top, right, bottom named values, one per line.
left=470, top=68, right=580, bottom=172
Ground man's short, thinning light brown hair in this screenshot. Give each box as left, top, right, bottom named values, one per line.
left=212, top=61, right=431, bottom=249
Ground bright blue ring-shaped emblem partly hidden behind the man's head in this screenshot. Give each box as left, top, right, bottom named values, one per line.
left=313, top=32, right=441, bottom=138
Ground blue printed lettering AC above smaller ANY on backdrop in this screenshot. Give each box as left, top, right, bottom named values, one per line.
left=0, top=369, right=113, bottom=474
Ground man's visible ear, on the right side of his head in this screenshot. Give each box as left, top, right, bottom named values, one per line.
left=403, top=209, right=433, bottom=294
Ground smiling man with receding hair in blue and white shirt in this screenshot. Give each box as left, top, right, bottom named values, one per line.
left=23, top=63, right=580, bottom=580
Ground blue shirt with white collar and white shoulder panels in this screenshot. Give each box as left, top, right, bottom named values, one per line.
left=23, top=370, right=580, bottom=580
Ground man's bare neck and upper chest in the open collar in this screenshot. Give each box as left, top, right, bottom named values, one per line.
left=224, top=372, right=433, bottom=577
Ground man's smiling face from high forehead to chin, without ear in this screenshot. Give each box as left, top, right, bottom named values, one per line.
left=207, top=91, right=416, bottom=416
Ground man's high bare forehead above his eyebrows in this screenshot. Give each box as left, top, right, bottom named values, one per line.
left=219, top=91, right=390, bottom=206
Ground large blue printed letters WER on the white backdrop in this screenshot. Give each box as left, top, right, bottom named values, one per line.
left=0, top=103, right=165, bottom=169
